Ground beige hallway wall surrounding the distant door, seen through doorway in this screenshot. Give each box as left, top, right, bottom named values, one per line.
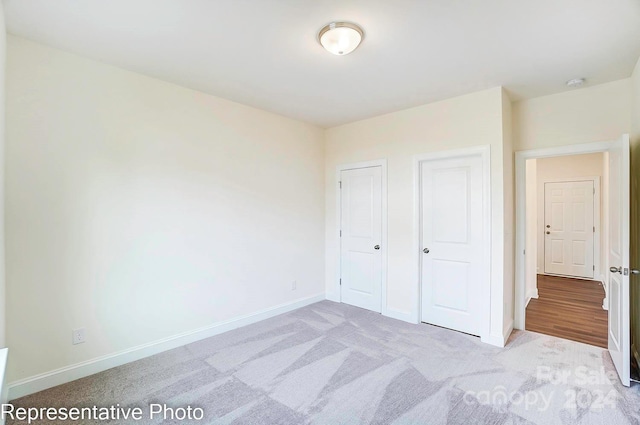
left=536, top=153, right=606, bottom=279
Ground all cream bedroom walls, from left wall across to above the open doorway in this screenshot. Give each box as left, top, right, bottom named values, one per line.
left=5, top=29, right=640, bottom=390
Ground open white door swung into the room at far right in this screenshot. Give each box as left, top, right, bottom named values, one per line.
left=607, top=135, right=631, bottom=386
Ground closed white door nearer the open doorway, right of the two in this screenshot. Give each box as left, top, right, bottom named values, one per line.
left=420, top=155, right=484, bottom=335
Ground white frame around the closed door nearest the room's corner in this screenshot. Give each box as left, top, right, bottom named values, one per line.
left=335, top=159, right=388, bottom=316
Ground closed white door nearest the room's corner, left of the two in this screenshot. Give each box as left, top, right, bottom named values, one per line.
left=340, top=166, right=384, bottom=313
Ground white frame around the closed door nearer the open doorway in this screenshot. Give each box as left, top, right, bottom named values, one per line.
left=413, top=145, right=491, bottom=341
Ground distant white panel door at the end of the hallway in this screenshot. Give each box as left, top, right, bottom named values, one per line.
left=544, top=180, right=595, bottom=279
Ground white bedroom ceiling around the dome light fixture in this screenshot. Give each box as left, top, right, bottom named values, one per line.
left=4, top=0, right=640, bottom=127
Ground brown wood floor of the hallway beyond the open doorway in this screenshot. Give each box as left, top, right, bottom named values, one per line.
left=525, top=275, right=608, bottom=348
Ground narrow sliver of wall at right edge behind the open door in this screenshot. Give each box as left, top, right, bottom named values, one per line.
left=630, top=59, right=640, bottom=364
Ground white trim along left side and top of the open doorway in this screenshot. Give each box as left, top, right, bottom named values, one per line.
left=513, top=141, right=615, bottom=329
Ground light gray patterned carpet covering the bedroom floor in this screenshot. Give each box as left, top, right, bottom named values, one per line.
left=9, top=301, right=640, bottom=425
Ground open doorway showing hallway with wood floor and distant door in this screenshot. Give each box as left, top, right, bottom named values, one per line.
left=525, top=152, right=609, bottom=348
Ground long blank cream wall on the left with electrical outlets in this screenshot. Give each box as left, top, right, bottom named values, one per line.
left=6, top=36, right=325, bottom=381
